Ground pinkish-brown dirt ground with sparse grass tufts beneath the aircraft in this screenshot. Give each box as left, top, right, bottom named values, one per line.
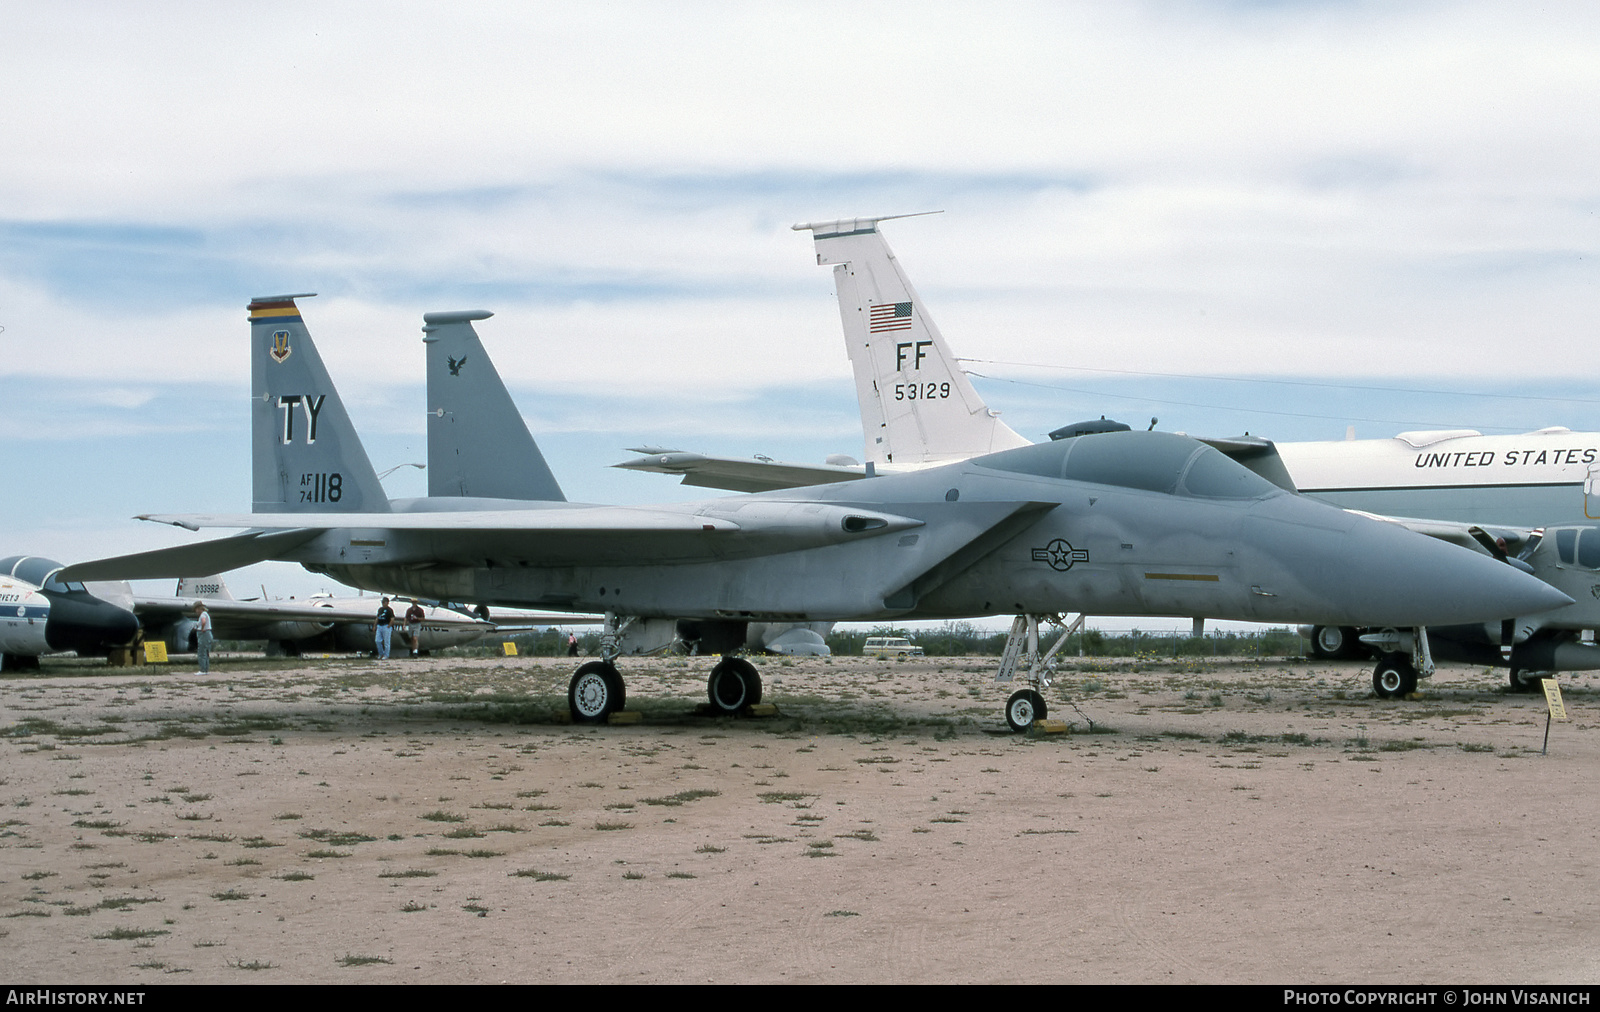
left=0, top=646, right=1600, bottom=983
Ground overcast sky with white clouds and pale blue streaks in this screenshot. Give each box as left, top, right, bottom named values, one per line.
left=0, top=0, right=1600, bottom=608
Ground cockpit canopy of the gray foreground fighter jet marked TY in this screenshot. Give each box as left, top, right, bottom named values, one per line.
left=989, top=432, right=1277, bottom=500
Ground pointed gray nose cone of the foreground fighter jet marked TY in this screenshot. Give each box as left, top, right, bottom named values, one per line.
left=1258, top=502, right=1571, bottom=626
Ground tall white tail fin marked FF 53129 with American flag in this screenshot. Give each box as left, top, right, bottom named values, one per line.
left=794, top=215, right=1029, bottom=464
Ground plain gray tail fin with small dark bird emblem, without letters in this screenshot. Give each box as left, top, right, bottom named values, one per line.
left=422, top=309, right=566, bottom=501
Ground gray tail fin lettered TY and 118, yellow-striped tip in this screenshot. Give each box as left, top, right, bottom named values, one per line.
left=250, top=295, right=389, bottom=512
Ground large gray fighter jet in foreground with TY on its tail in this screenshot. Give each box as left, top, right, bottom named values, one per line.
left=61, top=296, right=1571, bottom=729
